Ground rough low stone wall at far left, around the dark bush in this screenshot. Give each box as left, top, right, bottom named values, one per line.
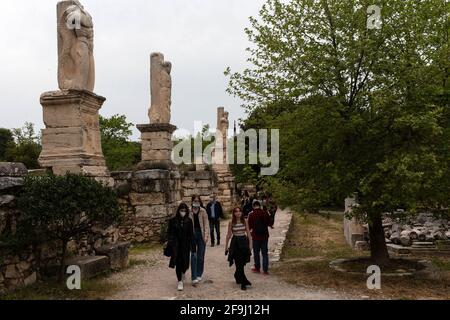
left=0, top=163, right=119, bottom=293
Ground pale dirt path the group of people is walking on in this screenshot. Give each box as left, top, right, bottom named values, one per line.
left=106, top=211, right=352, bottom=300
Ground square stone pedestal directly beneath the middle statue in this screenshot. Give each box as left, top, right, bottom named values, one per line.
left=137, top=123, right=177, bottom=170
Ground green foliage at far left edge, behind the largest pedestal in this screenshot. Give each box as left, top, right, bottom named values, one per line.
left=0, top=122, right=42, bottom=169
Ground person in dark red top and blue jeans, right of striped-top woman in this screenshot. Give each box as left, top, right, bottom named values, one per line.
left=248, top=201, right=273, bottom=275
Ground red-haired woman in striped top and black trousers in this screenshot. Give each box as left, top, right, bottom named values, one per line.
left=225, top=208, right=252, bottom=290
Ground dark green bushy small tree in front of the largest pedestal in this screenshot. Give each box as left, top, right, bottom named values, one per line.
left=12, top=174, right=122, bottom=280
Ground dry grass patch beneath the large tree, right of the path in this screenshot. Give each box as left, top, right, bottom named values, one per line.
left=272, top=211, right=450, bottom=299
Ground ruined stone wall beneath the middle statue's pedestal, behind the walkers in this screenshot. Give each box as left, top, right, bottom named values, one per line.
left=112, top=169, right=217, bottom=243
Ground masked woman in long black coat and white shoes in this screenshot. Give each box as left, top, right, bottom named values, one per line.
left=164, top=203, right=196, bottom=291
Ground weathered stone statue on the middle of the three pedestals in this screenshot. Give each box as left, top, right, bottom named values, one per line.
left=148, top=53, right=172, bottom=124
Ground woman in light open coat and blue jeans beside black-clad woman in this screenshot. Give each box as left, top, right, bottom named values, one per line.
left=189, top=195, right=209, bottom=286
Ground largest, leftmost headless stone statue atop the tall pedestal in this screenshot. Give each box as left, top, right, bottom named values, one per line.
left=57, top=0, right=95, bottom=92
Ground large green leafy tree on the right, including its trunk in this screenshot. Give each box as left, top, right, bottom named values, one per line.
left=226, top=0, right=450, bottom=265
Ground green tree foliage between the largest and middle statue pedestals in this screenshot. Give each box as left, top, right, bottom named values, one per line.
left=100, top=115, right=141, bottom=171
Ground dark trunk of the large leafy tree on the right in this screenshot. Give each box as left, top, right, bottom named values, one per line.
left=369, top=213, right=389, bottom=266
